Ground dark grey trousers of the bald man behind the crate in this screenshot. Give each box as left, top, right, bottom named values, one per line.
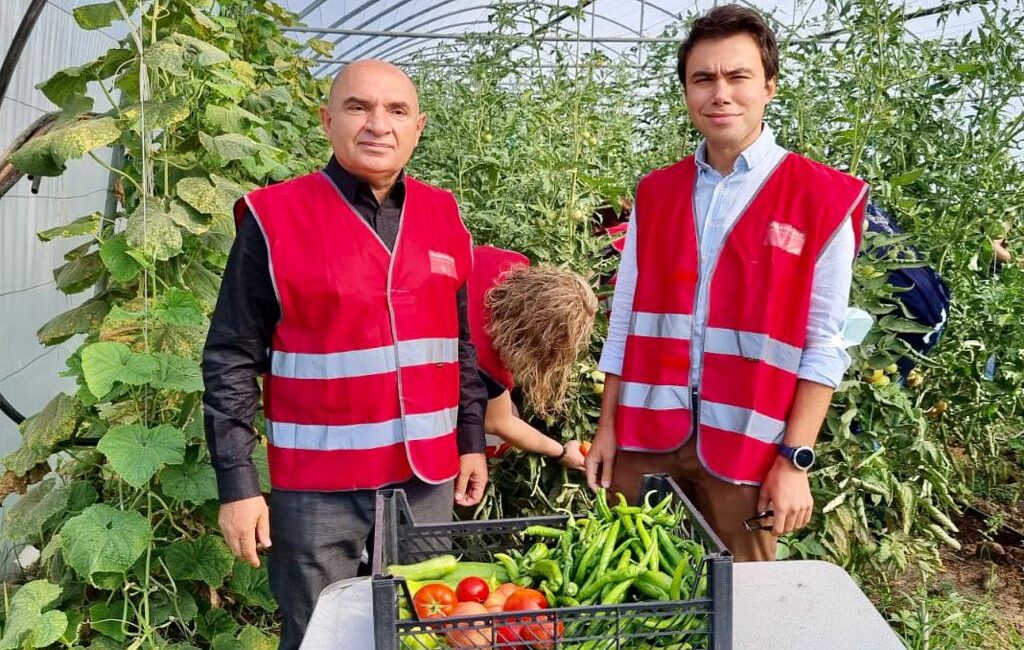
left=269, top=478, right=455, bottom=650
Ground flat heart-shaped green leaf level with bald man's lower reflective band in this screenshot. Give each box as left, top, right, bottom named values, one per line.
left=96, top=425, right=185, bottom=487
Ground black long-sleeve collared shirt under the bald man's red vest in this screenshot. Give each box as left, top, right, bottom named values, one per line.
left=203, top=158, right=486, bottom=503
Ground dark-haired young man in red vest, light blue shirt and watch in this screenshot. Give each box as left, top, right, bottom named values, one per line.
left=587, top=5, right=867, bottom=561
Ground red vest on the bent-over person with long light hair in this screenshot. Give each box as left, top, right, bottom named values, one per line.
left=467, top=246, right=529, bottom=458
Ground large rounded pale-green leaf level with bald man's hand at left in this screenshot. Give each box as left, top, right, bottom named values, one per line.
left=60, top=504, right=153, bottom=581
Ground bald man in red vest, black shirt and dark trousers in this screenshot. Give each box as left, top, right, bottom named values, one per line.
left=203, top=60, right=486, bottom=648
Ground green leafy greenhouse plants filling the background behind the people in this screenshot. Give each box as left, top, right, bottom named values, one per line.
left=0, top=0, right=1024, bottom=649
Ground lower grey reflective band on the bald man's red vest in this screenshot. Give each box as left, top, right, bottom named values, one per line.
left=266, top=407, right=459, bottom=451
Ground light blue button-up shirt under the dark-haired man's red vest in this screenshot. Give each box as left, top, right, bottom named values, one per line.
left=598, top=125, right=855, bottom=388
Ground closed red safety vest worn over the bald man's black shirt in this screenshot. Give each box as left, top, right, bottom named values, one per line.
left=237, top=173, right=472, bottom=491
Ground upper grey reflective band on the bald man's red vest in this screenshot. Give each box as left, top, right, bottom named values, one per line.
left=270, top=339, right=459, bottom=379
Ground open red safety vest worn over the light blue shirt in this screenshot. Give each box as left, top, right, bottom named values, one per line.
left=615, top=154, right=867, bottom=484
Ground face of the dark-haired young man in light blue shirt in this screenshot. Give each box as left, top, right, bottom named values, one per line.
left=685, top=34, right=775, bottom=155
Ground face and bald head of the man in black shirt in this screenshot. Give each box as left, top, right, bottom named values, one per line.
left=321, top=61, right=427, bottom=181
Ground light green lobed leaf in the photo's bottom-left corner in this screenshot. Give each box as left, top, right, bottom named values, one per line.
left=0, top=580, right=68, bottom=650
